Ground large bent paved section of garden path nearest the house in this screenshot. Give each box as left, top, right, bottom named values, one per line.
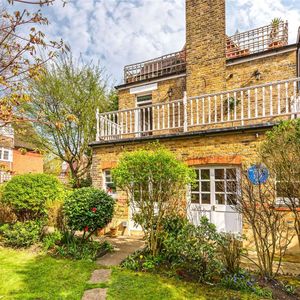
left=97, top=237, right=145, bottom=267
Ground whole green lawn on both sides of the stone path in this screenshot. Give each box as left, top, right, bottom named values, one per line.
left=0, top=248, right=258, bottom=300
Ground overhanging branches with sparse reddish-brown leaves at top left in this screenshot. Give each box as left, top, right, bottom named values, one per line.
left=0, top=0, right=68, bottom=126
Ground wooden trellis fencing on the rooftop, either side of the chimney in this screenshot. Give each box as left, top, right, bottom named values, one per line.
left=124, top=21, right=288, bottom=84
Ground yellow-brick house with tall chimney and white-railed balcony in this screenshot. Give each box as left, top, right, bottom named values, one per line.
left=91, top=0, right=300, bottom=239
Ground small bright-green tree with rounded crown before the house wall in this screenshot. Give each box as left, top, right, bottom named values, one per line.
left=113, top=144, right=195, bottom=255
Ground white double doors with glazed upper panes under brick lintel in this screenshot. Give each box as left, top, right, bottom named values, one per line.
left=187, top=166, right=242, bottom=233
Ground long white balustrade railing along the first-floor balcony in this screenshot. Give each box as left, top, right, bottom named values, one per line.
left=97, top=78, right=300, bottom=141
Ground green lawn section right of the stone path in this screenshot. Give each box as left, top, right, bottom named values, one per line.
left=108, top=269, right=259, bottom=300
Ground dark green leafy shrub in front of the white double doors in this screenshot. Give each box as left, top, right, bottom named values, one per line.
left=162, top=216, right=222, bottom=281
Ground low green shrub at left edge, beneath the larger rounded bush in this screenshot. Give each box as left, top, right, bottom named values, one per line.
left=0, top=221, right=43, bottom=248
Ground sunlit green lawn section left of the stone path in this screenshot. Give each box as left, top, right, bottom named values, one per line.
left=0, top=248, right=95, bottom=300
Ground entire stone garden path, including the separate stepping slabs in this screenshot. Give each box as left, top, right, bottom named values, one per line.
left=82, top=236, right=145, bottom=300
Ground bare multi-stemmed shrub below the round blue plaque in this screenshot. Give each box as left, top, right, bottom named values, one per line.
left=234, top=171, right=294, bottom=278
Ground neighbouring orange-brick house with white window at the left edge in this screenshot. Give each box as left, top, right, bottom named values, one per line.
left=0, top=126, right=43, bottom=183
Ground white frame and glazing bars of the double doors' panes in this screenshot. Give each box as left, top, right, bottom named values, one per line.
left=190, top=165, right=240, bottom=206
